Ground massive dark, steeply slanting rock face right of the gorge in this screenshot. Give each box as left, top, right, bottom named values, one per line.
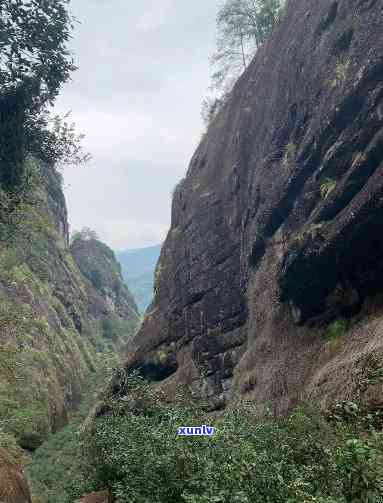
left=126, top=0, right=383, bottom=412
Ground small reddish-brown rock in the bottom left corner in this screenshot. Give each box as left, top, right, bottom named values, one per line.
left=0, top=448, right=32, bottom=503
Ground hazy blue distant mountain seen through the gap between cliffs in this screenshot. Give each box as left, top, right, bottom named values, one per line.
left=116, top=245, right=162, bottom=313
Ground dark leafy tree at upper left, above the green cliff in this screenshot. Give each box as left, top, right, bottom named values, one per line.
left=0, top=0, right=88, bottom=189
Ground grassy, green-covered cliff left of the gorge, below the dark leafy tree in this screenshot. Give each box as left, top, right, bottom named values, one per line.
left=0, top=160, right=138, bottom=450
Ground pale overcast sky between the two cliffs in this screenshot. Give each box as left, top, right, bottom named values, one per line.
left=56, top=0, right=218, bottom=250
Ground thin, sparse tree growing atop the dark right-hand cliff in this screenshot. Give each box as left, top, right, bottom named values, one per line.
left=202, top=0, right=284, bottom=126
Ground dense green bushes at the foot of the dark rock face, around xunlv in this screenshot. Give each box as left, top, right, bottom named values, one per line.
left=55, top=376, right=383, bottom=503
